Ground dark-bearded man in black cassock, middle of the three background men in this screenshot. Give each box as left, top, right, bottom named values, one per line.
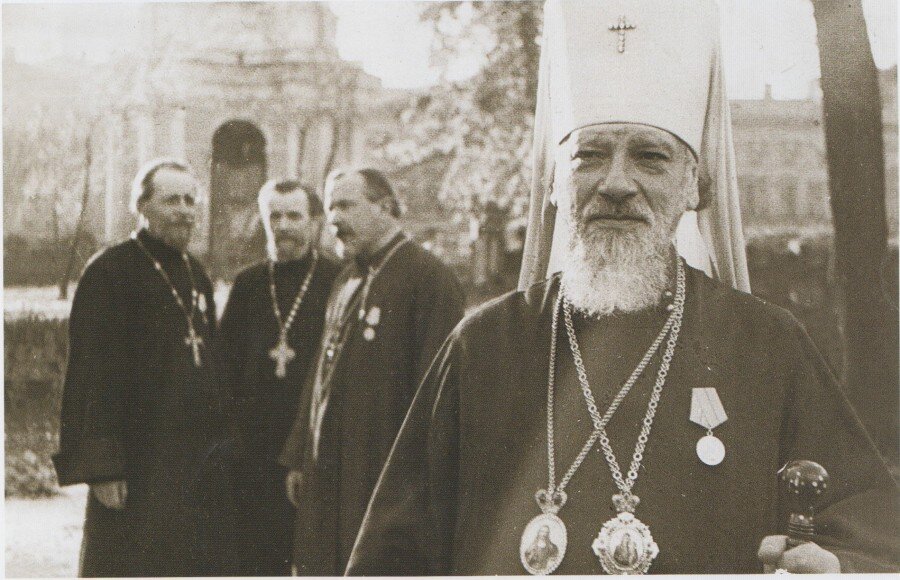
left=217, top=181, right=338, bottom=576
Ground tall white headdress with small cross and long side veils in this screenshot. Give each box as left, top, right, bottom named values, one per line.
left=519, top=0, right=750, bottom=291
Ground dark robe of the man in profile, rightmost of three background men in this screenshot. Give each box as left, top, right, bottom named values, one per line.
left=281, top=239, right=464, bottom=575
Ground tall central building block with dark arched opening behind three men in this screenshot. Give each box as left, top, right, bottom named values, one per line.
left=93, top=2, right=400, bottom=278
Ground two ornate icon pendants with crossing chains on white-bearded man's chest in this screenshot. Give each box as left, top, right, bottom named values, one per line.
left=519, top=259, right=685, bottom=574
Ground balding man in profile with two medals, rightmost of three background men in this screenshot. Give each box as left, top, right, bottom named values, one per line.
left=281, top=169, right=464, bottom=576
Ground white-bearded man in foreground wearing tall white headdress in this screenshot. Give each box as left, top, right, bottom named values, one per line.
left=348, top=0, right=900, bottom=575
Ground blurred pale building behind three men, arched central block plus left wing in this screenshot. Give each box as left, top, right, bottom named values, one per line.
left=3, top=2, right=402, bottom=278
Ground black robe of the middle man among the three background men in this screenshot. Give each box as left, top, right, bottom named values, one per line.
left=217, top=255, right=338, bottom=576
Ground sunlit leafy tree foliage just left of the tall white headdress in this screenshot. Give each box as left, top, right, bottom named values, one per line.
left=372, top=1, right=541, bottom=220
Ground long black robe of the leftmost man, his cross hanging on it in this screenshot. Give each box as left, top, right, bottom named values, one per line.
left=53, top=231, right=236, bottom=576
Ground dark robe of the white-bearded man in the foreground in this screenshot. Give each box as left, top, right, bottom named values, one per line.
left=348, top=270, right=898, bottom=575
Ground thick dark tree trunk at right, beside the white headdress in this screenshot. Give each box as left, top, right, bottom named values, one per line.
left=813, top=0, right=900, bottom=462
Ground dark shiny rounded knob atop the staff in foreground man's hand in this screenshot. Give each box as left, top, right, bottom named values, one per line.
left=778, top=459, right=828, bottom=547
